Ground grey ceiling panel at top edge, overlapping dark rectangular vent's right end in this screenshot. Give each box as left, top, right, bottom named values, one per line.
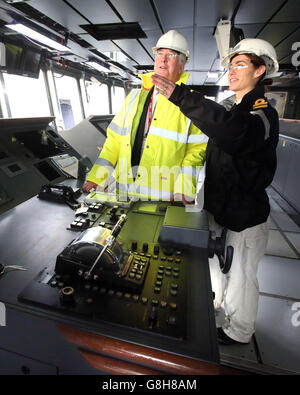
left=111, top=0, right=159, bottom=30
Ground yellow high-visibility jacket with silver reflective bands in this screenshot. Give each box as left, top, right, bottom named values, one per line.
left=87, top=73, right=208, bottom=200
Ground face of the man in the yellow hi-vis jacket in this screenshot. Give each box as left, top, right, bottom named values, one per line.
left=154, top=48, right=184, bottom=82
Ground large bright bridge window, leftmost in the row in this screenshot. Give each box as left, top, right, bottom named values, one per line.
left=3, top=72, right=51, bottom=118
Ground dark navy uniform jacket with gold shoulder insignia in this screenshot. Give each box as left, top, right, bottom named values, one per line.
left=169, top=83, right=279, bottom=232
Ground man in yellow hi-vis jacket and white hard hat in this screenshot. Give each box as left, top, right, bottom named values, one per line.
left=83, top=30, right=208, bottom=204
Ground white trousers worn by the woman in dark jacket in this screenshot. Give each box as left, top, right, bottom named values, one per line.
left=208, top=213, right=269, bottom=343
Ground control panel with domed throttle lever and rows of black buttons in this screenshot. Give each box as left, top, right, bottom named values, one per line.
left=19, top=203, right=189, bottom=340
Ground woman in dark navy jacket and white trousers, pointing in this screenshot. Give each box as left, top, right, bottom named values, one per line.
left=152, top=38, right=279, bottom=344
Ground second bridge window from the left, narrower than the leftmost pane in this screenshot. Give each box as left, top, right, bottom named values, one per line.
left=54, top=73, right=83, bottom=129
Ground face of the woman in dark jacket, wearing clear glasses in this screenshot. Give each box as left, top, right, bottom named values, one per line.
left=228, top=55, right=266, bottom=95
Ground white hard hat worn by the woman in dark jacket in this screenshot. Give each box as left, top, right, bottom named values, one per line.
left=222, top=38, right=279, bottom=78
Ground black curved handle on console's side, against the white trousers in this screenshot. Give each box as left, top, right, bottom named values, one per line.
left=208, top=228, right=233, bottom=274
